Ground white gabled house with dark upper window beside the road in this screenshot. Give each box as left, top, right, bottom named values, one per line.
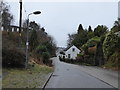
left=65, top=45, right=81, bottom=60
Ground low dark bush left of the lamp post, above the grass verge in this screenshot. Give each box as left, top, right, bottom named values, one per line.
left=2, top=49, right=26, bottom=67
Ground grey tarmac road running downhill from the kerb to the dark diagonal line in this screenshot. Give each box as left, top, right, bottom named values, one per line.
left=45, top=57, right=118, bottom=88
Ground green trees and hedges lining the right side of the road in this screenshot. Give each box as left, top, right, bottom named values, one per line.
left=64, top=18, right=120, bottom=70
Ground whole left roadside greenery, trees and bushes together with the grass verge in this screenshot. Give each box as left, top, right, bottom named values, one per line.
left=0, top=1, right=56, bottom=88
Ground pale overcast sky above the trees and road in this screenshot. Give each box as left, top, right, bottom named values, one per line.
left=6, top=0, right=118, bottom=47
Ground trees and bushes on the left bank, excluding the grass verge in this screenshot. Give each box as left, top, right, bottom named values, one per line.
left=0, top=1, right=56, bottom=67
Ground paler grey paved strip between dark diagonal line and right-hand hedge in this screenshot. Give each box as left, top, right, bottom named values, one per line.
left=74, top=66, right=118, bottom=88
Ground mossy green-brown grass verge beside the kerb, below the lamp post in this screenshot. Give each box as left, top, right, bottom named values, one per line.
left=2, top=64, right=53, bottom=88
